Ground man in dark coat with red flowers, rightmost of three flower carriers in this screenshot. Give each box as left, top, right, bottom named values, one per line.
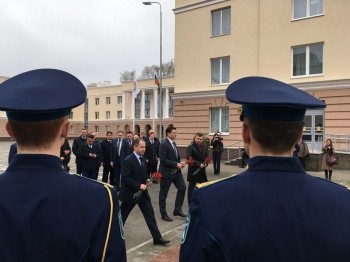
left=186, top=132, right=208, bottom=205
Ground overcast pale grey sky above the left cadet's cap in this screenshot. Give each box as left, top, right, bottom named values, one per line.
left=0, top=0, right=175, bottom=84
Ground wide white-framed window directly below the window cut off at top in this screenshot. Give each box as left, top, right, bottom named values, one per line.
left=292, top=43, right=323, bottom=76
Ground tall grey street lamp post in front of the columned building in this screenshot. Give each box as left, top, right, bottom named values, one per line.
left=142, top=2, right=163, bottom=141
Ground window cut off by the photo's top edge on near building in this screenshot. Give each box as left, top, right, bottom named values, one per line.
left=293, top=0, right=323, bottom=19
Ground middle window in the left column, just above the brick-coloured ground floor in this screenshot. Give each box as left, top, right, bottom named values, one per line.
left=211, top=56, right=230, bottom=85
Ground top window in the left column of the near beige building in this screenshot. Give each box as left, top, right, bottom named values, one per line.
left=211, top=7, right=231, bottom=36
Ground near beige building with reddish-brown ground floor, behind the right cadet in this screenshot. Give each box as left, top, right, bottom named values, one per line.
left=173, top=0, right=350, bottom=150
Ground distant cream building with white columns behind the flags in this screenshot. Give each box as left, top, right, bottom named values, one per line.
left=85, top=77, right=174, bottom=139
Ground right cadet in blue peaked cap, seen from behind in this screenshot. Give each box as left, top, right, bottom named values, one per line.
left=180, top=77, right=350, bottom=261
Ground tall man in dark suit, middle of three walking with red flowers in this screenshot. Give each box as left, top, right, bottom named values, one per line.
left=159, top=125, right=186, bottom=222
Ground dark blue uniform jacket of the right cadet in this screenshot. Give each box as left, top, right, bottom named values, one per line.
left=180, top=157, right=350, bottom=262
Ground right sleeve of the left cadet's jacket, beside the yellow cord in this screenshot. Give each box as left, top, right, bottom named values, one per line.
left=89, top=189, right=127, bottom=262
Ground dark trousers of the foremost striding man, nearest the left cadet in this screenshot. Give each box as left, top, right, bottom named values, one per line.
left=120, top=196, right=162, bottom=240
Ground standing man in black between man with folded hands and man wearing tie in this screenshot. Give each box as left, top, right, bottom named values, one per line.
left=101, top=131, right=115, bottom=186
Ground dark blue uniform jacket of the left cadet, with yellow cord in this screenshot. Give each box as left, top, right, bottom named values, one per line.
left=0, top=154, right=126, bottom=261
